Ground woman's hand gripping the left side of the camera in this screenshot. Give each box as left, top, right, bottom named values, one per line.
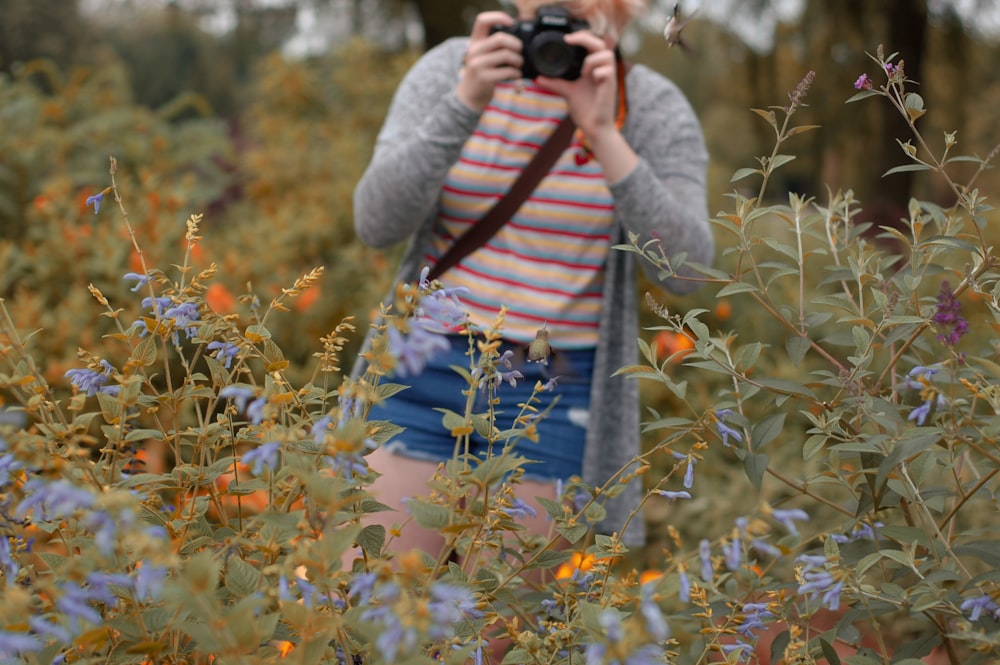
left=456, top=12, right=523, bottom=111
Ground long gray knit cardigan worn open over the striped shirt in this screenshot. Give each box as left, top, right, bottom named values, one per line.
left=354, top=38, right=714, bottom=545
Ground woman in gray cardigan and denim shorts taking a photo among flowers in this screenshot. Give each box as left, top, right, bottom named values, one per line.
left=354, top=0, right=714, bottom=551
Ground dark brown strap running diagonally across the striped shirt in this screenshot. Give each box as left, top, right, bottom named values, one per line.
left=427, top=115, right=576, bottom=280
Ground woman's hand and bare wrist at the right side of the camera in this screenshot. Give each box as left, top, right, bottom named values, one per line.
left=536, top=31, right=639, bottom=184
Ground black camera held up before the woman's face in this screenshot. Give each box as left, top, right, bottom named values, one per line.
left=490, top=5, right=589, bottom=81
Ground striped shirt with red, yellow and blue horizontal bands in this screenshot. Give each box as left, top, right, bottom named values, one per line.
left=424, top=81, right=614, bottom=349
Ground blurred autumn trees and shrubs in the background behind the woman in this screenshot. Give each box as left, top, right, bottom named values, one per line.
left=0, top=0, right=1000, bottom=548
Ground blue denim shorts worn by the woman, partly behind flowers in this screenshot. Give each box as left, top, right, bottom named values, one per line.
left=369, top=336, right=594, bottom=481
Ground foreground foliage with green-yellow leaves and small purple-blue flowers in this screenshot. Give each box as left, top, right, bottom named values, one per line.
left=0, top=44, right=1000, bottom=665
